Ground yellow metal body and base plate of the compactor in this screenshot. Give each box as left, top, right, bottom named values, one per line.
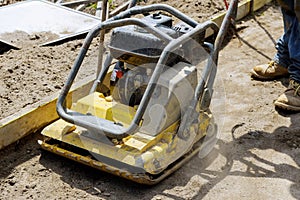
left=39, top=89, right=211, bottom=184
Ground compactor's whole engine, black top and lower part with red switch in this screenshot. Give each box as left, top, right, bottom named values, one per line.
left=108, top=13, right=204, bottom=110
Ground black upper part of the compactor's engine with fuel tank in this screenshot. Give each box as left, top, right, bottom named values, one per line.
left=109, top=13, right=204, bottom=66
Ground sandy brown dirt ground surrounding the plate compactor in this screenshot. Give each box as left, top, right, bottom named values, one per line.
left=0, top=1, right=300, bottom=200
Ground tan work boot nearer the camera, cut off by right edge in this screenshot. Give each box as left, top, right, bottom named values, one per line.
left=274, top=80, right=300, bottom=112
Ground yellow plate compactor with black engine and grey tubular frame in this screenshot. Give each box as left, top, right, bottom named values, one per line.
left=38, top=0, right=237, bottom=185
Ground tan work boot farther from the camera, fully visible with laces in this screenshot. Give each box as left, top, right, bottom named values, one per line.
left=251, top=61, right=289, bottom=80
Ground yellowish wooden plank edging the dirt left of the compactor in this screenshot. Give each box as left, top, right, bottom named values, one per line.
left=0, top=75, right=95, bottom=149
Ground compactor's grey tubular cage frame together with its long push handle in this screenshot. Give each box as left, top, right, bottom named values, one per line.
left=56, top=0, right=237, bottom=139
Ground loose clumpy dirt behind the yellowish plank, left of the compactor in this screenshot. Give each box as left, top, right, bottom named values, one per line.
left=0, top=31, right=97, bottom=120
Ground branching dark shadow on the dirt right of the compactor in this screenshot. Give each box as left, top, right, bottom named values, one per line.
left=194, top=113, right=300, bottom=199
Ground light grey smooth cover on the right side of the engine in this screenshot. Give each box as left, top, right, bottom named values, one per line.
left=140, top=62, right=197, bottom=136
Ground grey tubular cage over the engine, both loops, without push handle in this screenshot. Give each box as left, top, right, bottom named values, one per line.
left=56, top=5, right=218, bottom=138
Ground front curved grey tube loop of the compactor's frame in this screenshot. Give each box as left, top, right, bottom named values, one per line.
left=57, top=17, right=218, bottom=138
